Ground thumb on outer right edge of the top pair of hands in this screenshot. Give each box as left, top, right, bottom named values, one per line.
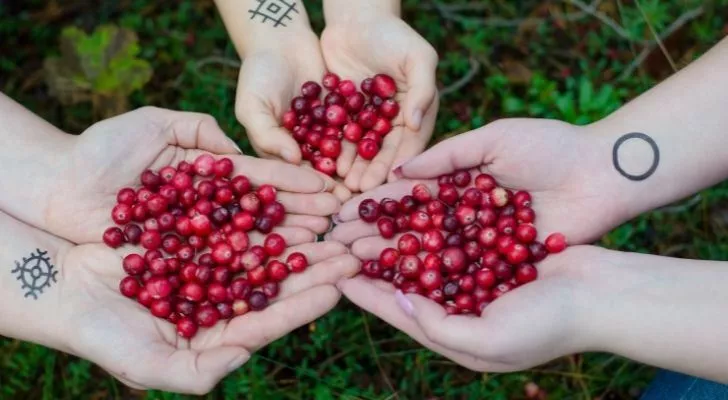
left=403, top=45, right=438, bottom=132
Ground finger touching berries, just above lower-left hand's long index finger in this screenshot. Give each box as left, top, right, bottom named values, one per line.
left=276, top=254, right=361, bottom=301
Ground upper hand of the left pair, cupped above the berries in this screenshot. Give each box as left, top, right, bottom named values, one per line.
left=44, top=107, right=340, bottom=243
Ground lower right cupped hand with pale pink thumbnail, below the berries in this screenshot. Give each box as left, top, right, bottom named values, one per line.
left=338, top=246, right=605, bottom=372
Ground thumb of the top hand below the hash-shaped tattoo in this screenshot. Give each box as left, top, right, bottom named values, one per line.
left=235, top=101, right=302, bottom=164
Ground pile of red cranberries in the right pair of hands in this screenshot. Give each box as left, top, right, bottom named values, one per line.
left=359, top=171, right=567, bottom=315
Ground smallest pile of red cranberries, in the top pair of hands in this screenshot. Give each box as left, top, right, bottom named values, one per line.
left=282, top=72, right=399, bottom=176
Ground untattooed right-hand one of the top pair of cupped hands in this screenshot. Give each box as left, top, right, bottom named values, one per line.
left=321, top=12, right=439, bottom=192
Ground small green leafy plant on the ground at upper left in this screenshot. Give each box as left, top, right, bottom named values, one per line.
left=44, top=25, right=152, bottom=118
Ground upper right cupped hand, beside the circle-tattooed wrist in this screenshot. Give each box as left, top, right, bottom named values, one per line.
left=329, top=119, right=624, bottom=248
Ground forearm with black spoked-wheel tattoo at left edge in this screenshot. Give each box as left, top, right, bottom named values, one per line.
left=0, top=212, right=70, bottom=352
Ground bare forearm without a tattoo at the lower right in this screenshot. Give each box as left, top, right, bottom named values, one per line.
left=587, top=251, right=728, bottom=383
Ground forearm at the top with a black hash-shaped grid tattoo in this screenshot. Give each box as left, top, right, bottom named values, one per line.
left=215, top=0, right=315, bottom=58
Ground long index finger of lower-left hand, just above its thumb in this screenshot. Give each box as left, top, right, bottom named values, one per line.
left=223, top=286, right=341, bottom=351
